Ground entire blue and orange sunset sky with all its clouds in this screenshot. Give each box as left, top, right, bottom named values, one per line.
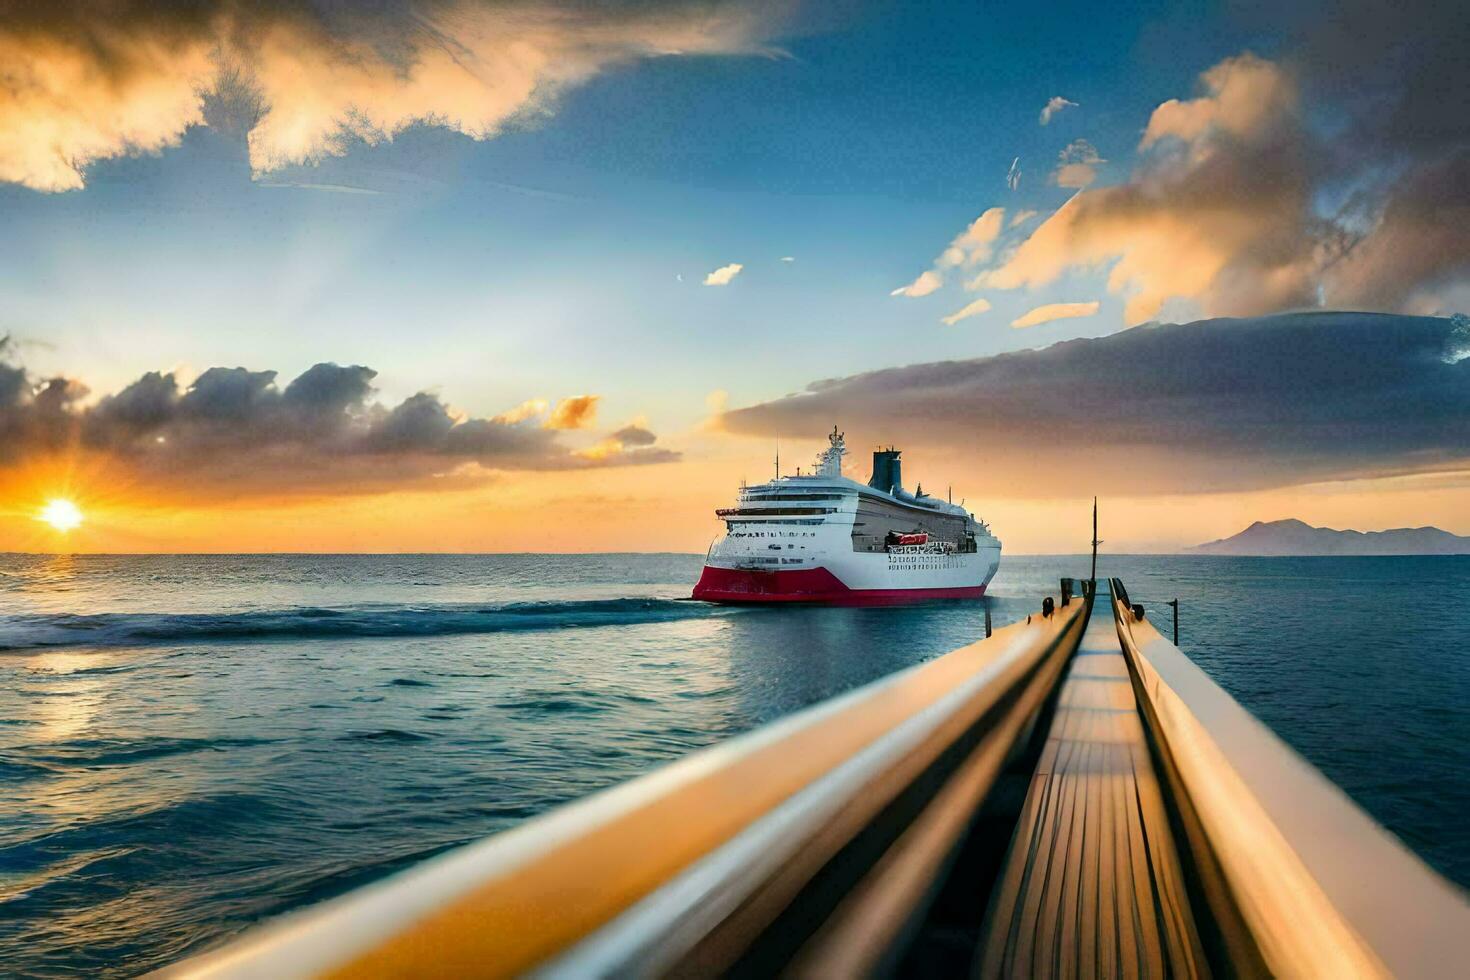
left=0, top=0, right=1470, bottom=554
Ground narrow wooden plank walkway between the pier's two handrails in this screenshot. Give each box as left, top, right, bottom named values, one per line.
left=976, top=594, right=1208, bottom=977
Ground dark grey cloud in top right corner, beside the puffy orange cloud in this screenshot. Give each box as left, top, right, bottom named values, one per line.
left=1270, top=0, right=1470, bottom=311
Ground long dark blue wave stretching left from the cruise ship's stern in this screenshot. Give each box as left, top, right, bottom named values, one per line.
left=0, top=598, right=736, bottom=651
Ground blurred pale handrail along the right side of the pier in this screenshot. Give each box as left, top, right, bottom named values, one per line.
left=1113, top=589, right=1470, bottom=977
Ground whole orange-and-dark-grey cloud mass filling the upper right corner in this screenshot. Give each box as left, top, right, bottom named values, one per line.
left=973, top=17, right=1470, bottom=325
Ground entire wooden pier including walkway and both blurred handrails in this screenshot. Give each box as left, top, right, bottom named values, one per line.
left=163, top=580, right=1470, bottom=977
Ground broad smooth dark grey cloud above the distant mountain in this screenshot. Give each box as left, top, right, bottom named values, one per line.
left=722, top=313, right=1470, bottom=495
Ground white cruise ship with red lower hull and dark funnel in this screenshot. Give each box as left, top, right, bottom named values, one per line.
left=694, top=428, right=1001, bottom=605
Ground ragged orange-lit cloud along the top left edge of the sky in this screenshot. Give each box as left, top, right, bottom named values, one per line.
left=0, top=0, right=787, bottom=191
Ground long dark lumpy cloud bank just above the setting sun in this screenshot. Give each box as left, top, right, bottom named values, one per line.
left=0, top=341, right=679, bottom=495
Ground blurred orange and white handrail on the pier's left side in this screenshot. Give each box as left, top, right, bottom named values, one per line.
left=162, top=602, right=1086, bottom=977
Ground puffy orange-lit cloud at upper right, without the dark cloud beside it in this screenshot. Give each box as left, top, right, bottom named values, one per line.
left=976, top=54, right=1319, bottom=325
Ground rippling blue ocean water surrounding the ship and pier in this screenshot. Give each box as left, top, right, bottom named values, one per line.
left=0, top=555, right=1470, bottom=976
